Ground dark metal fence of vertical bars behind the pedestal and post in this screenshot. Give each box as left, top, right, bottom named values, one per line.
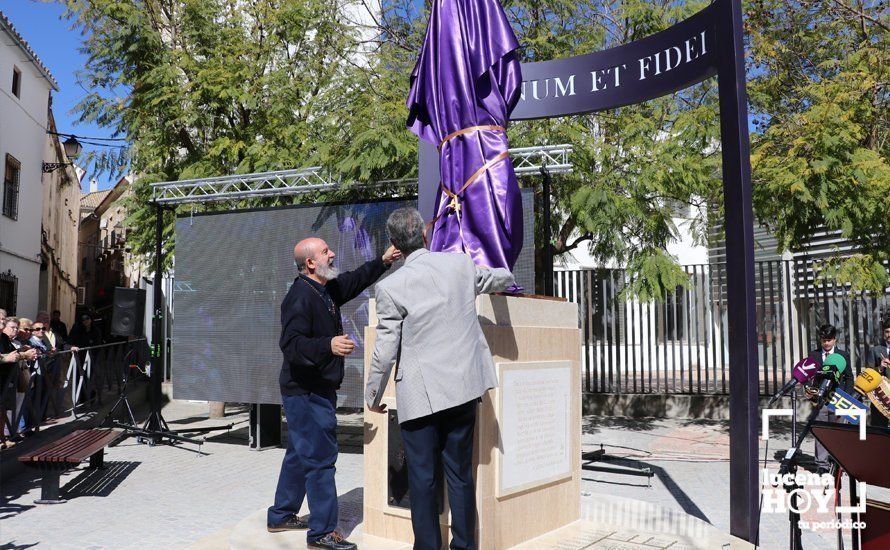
left=554, top=260, right=890, bottom=395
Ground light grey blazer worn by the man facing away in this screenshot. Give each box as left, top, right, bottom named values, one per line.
left=365, top=249, right=514, bottom=422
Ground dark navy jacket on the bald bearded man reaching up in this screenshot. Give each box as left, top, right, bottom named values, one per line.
left=278, top=258, right=389, bottom=395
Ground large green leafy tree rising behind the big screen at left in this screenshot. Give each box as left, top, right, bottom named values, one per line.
left=66, top=0, right=374, bottom=266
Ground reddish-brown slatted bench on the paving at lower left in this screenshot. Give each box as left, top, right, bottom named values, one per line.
left=19, top=429, right=122, bottom=504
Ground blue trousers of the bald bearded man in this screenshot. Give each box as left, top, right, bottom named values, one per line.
left=267, top=391, right=337, bottom=542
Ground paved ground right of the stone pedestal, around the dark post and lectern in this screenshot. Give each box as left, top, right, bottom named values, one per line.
left=582, top=417, right=850, bottom=549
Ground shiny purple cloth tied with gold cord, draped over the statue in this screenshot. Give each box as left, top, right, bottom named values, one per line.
left=408, top=0, right=522, bottom=269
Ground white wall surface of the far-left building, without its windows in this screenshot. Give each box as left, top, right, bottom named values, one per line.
left=0, top=31, right=51, bottom=317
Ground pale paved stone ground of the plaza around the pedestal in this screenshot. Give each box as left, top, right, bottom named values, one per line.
left=0, top=401, right=849, bottom=550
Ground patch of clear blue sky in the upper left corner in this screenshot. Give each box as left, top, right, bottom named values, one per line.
left=0, top=0, right=122, bottom=193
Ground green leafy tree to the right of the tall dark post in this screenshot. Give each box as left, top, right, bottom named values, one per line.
left=747, top=0, right=890, bottom=291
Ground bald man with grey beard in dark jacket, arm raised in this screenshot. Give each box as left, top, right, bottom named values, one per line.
left=266, top=237, right=401, bottom=550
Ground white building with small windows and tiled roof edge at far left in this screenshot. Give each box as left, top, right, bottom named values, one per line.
left=0, top=12, right=59, bottom=317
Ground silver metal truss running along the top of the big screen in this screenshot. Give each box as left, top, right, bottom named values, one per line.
left=151, top=144, right=572, bottom=205
